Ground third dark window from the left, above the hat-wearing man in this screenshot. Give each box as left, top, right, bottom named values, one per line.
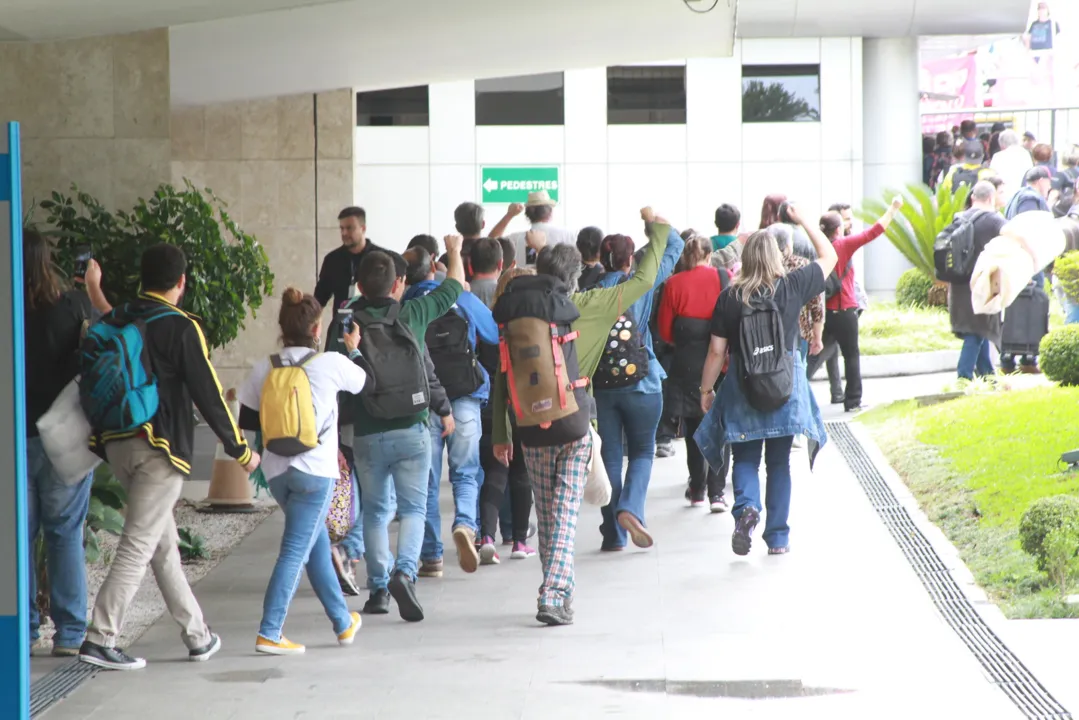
left=607, top=65, right=685, bottom=125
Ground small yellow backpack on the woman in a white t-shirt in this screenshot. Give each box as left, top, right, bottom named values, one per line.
left=259, top=352, right=318, bottom=458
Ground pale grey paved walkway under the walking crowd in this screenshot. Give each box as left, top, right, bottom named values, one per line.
left=44, top=431, right=1020, bottom=720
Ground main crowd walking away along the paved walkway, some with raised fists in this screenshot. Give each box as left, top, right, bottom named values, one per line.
left=26, top=184, right=900, bottom=669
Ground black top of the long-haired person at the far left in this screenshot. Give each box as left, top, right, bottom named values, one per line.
left=25, top=290, right=91, bottom=437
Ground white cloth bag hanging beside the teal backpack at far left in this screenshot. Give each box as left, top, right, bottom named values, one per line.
left=37, top=379, right=101, bottom=485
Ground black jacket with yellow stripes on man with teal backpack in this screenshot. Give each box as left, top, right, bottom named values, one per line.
left=91, top=294, right=251, bottom=475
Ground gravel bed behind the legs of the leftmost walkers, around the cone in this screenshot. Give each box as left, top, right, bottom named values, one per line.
left=35, top=492, right=276, bottom=648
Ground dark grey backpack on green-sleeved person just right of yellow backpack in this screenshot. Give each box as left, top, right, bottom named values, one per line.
left=353, top=302, right=431, bottom=420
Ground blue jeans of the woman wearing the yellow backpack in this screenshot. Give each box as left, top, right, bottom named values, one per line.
left=259, top=467, right=352, bottom=642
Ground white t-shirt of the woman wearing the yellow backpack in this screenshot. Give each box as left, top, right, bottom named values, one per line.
left=240, top=348, right=367, bottom=480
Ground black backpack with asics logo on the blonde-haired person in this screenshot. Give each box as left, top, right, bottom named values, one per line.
left=738, top=294, right=794, bottom=412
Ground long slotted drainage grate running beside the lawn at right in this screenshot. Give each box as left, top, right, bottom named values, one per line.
left=828, top=422, right=1071, bottom=720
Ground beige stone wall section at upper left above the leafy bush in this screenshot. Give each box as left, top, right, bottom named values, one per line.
left=0, top=29, right=170, bottom=219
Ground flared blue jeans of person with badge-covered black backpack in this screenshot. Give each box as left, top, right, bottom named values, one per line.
left=596, top=390, right=664, bottom=547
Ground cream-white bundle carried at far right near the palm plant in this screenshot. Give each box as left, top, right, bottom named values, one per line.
left=970, top=210, right=1066, bottom=315
